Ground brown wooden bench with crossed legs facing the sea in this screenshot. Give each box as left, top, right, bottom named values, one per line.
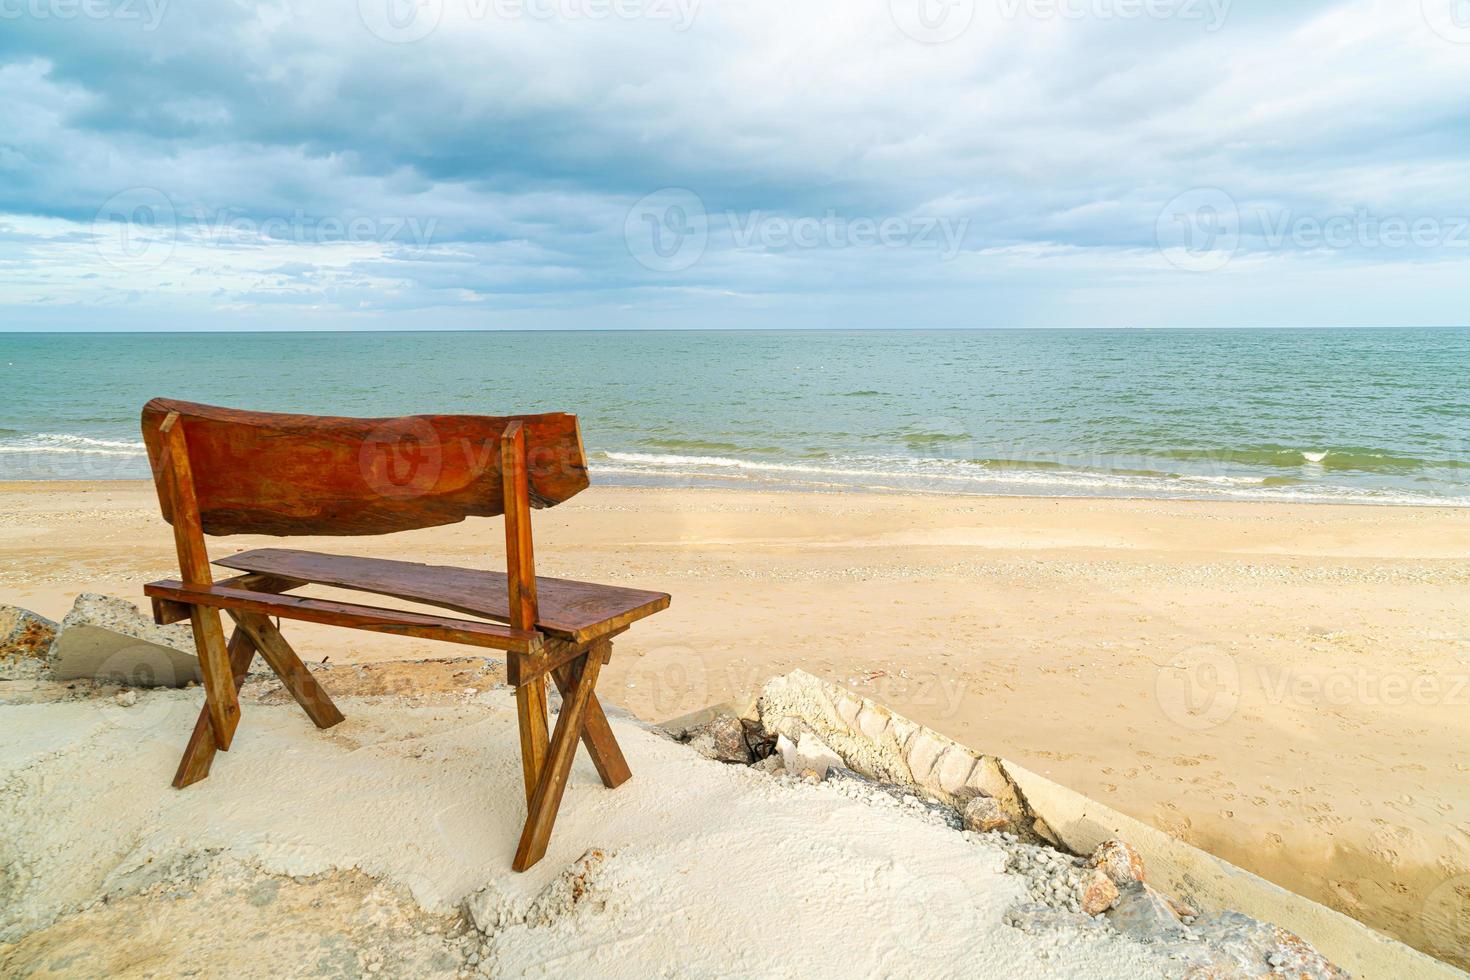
left=143, top=398, right=669, bottom=871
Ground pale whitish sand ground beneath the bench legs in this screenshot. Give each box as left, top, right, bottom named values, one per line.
left=0, top=691, right=1169, bottom=979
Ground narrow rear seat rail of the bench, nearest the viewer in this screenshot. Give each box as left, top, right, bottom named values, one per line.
left=143, top=580, right=541, bottom=654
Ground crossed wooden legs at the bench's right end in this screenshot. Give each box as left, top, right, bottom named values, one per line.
left=512, top=639, right=632, bottom=871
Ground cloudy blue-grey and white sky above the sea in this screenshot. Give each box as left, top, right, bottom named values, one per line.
left=0, top=0, right=1470, bottom=331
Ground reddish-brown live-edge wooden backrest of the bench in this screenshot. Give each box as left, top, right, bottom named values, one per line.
left=143, top=398, right=588, bottom=535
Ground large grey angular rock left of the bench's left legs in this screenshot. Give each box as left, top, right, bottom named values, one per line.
left=51, top=592, right=201, bottom=688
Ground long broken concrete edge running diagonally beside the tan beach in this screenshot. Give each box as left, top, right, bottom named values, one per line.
left=657, top=670, right=1466, bottom=980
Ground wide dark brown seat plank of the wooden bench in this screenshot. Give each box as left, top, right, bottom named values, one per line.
left=215, top=548, right=669, bottom=644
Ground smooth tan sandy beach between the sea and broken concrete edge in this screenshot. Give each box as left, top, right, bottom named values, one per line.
left=0, top=482, right=1470, bottom=965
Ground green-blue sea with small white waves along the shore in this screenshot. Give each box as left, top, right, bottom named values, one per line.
left=0, top=329, right=1470, bottom=505
